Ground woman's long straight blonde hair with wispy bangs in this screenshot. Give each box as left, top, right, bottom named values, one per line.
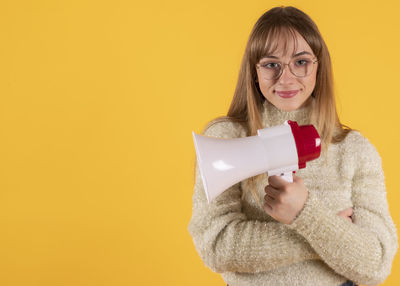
left=197, top=6, right=352, bottom=201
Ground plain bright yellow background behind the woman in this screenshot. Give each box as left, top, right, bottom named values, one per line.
left=0, top=0, right=400, bottom=286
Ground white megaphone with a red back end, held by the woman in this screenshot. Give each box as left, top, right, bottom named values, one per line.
left=192, top=120, right=321, bottom=203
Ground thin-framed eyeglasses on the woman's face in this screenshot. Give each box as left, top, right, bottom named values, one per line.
left=256, top=57, right=318, bottom=80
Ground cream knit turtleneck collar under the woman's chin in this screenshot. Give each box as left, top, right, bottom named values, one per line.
left=261, top=100, right=313, bottom=128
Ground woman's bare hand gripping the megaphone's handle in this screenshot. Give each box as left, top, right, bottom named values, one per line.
left=264, top=174, right=308, bottom=224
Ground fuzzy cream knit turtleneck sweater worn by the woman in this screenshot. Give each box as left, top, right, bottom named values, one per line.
left=189, top=101, right=398, bottom=286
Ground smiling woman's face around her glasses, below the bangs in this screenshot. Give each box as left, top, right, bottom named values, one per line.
left=257, top=32, right=318, bottom=111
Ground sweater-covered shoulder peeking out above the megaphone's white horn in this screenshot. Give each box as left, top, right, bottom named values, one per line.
left=202, top=116, right=247, bottom=139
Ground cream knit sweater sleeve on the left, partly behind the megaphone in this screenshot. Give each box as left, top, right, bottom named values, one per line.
left=188, top=120, right=321, bottom=273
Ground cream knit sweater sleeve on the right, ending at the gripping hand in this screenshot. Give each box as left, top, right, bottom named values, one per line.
left=288, top=132, right=398, bottom=285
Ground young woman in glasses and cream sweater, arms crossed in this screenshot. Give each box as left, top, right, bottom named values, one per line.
left=189, top=7, right=398, bottom=286
